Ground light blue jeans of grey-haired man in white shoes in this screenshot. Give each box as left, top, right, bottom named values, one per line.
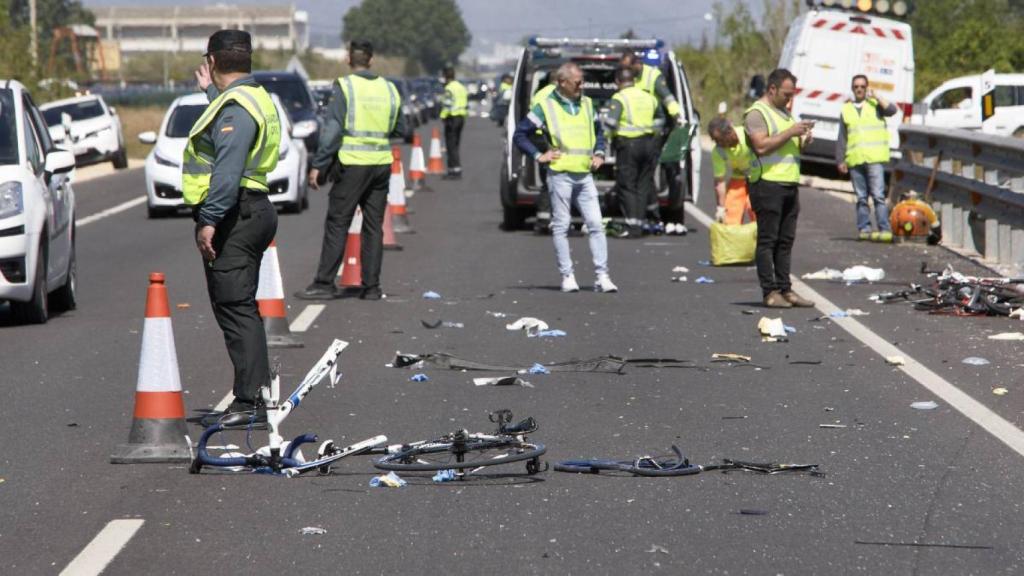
left=548, top=171, right=608, bottom=276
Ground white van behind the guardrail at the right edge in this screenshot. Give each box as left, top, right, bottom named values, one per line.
left=913, top=71, right=1024, bottom=138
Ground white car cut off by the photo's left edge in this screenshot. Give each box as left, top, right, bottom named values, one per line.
left=0, top=80, right=76, bottom=324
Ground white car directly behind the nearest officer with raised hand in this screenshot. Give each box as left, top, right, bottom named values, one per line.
left=138, top=93, right=309, bottom=218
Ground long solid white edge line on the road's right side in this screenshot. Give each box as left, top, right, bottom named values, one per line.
left=686, top=204, right=1024, bottom=456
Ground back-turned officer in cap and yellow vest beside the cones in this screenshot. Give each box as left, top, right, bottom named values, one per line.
left=295, top=40, right=406, bottom=300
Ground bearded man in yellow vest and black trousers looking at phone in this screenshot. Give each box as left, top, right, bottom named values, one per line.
left=743, top=68, right=814, bottom=308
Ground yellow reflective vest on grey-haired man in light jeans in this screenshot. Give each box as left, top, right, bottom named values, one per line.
left=544, top=96, right=597, bottom=172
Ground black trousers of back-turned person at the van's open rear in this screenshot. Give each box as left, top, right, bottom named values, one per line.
left=615, top=136, right=657, bottom=225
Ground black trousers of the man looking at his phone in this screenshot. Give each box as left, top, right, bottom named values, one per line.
left=749, top=180, right=800, bottom=296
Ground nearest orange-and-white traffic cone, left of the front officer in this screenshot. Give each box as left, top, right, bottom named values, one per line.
left=111, top=272, right=190, bottom=464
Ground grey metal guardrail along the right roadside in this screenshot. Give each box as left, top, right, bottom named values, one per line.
left=892, top=124, right=1024, bottom=275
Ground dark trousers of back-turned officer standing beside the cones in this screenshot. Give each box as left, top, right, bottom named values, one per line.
left=314, top=164, right=391, bottom=288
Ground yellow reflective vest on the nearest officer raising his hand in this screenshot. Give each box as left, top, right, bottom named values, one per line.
left=181, top=85, right=281, bottom=206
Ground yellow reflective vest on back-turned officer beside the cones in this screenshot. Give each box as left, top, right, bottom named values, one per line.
left=338, top=74, right=401, bottom=166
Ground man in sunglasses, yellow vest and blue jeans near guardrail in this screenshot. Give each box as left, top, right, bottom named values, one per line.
left=836, top=74, right=896, bottom=242
